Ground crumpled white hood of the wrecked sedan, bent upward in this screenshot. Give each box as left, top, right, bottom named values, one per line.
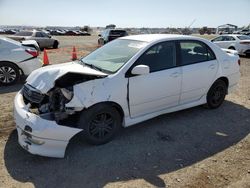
left=26, top=62, right=107, bottom=93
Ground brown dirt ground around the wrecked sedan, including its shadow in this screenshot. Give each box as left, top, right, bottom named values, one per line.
left=0, top=36, right=250, bottom=188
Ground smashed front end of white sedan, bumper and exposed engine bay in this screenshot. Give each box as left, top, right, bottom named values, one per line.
left=14, top=66, right=107, bottom=158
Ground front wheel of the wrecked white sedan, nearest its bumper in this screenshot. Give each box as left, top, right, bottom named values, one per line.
left=78, top=104, right=121, bottom=145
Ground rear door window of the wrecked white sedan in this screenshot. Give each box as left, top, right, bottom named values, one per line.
left=180, top=41, right=215, bottom=65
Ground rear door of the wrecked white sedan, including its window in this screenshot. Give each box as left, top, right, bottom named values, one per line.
left=179, top=40, right=218, bottom=104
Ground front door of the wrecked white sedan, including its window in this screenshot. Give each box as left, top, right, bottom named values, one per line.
left=128, top=42, right=182, bottom=118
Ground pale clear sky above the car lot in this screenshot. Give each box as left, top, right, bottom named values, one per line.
left=0, top=0, right=250, bottom=27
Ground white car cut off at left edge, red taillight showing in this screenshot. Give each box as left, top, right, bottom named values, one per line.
left=0, top=37, right=42, bottom=85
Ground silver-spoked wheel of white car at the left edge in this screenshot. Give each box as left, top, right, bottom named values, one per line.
left=0, top=62, right=20, bottom=86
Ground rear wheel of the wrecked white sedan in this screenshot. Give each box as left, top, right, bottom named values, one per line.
left=207, top=80, right=227, bottom=109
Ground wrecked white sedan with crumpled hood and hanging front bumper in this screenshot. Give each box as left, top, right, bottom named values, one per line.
left=14, top=35, right=240, bottom=157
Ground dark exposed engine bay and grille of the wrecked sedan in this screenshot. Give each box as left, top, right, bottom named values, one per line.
left=22, top=73, right=106, bottom=125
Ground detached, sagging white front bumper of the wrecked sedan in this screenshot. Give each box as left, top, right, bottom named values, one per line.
left=14, top=92, right=82, bottom=158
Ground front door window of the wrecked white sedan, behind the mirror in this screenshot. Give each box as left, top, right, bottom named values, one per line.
left=134, top=42, right=176, bottom=72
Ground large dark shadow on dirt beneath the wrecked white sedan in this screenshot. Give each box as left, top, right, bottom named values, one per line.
left=4, top=101, right=250, bottom=188
